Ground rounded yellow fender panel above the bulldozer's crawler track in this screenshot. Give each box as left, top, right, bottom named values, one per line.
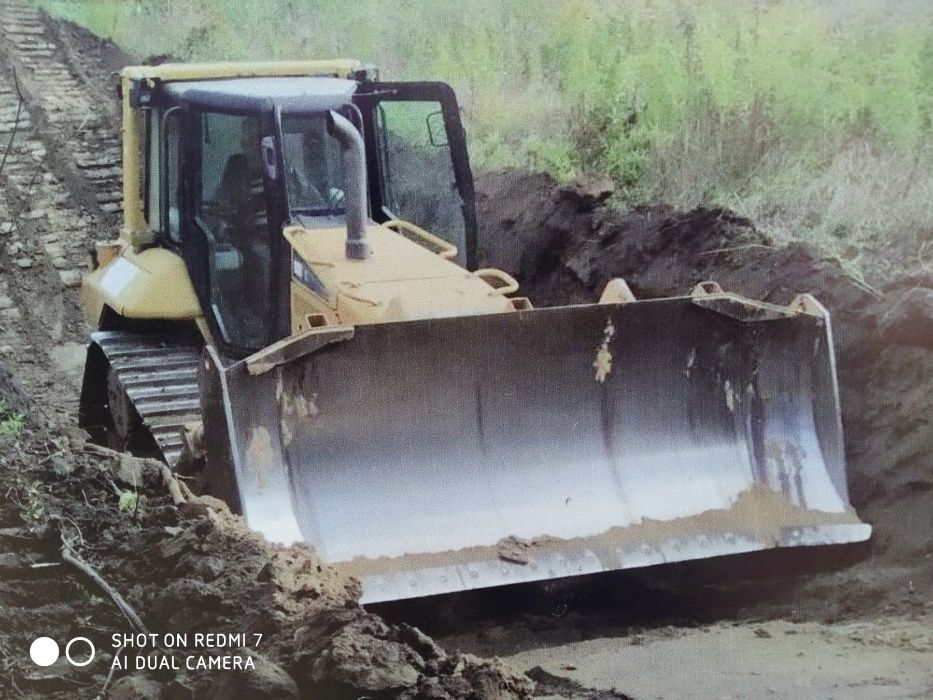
left=81, top=246, right=201, bottom=326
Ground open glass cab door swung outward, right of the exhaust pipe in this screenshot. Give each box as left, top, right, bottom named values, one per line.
left=354, top=82, right=476, bottom=269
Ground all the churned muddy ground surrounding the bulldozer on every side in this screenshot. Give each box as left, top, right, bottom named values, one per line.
left=0, top=5, right=933, bottom=698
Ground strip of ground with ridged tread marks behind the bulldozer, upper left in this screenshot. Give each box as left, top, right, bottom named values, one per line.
left=0, top=0, right=122, bottom=416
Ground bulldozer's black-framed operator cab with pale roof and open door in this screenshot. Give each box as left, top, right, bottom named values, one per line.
left=143, top=77, right=476, bottom=356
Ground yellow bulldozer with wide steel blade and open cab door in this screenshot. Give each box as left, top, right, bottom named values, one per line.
left=80, top=60, right=871, bottom=603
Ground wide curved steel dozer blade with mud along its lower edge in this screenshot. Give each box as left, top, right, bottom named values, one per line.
left=201, top=294, right=871, bottom=602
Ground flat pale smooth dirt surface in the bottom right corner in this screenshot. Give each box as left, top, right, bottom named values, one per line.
left=507, top=618, right=933, bottom=700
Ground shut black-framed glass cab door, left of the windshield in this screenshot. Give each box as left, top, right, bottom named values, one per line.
left=176, top=94, right=289, bottom=356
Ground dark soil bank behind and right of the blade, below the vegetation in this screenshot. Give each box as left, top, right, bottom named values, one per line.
left=477, top=172, right=933, bottom=608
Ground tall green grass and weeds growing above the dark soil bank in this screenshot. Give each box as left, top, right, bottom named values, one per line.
left=42, top=0, right=933, bottom=262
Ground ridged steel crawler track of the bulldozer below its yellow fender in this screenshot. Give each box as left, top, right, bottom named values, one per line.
left=80, top=331, right=201, bottom=467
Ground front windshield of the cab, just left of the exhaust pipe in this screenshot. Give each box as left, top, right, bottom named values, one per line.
left=282, top=114, right=345, bottom=214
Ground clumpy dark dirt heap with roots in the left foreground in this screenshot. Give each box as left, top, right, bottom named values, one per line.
left=0, top=368, right=533, bottom=698
